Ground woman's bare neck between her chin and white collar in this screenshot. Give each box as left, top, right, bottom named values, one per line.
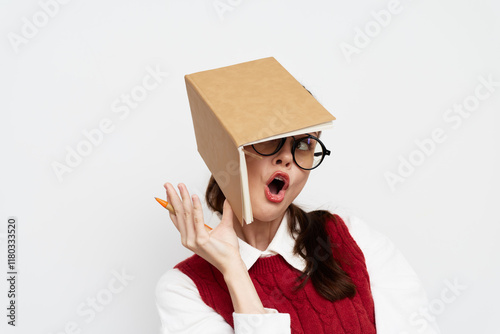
left=234, top=214, right=284, bottom=251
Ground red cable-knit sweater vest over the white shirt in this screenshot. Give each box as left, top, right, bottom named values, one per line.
left=175, top=215, right=376, bottom=334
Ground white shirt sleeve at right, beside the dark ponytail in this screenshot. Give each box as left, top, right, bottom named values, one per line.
left=342, top=216, right=440, bottom=334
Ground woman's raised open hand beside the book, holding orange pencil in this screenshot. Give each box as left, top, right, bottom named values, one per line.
left=165, top=183, right=242, bottom=274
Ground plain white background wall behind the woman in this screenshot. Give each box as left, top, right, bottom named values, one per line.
left=0, top=0, right=500, bottom=334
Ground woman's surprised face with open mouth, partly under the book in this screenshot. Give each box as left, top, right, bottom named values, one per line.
left=245, top=137, right=310, bottom=222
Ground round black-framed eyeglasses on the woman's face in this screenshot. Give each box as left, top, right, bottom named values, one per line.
left=252, top=135, right=331, bottom=170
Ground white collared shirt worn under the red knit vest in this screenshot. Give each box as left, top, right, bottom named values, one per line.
left=156, top=213, right=439, bottom=334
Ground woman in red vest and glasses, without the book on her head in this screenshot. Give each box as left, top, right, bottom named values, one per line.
left=157, top=133, right=440, bottom=334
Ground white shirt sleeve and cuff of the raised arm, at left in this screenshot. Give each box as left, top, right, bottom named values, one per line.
left=156, top=269, right=291, bottom=334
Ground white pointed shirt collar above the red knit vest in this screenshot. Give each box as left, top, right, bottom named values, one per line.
left=209, top=212, right=306, bottom=271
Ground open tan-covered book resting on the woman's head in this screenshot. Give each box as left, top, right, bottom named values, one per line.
left=185, top=57, right=335, bottom=224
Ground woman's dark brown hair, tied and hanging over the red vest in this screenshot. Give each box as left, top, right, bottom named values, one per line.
left=205, top=176, right=356, bottom=301
